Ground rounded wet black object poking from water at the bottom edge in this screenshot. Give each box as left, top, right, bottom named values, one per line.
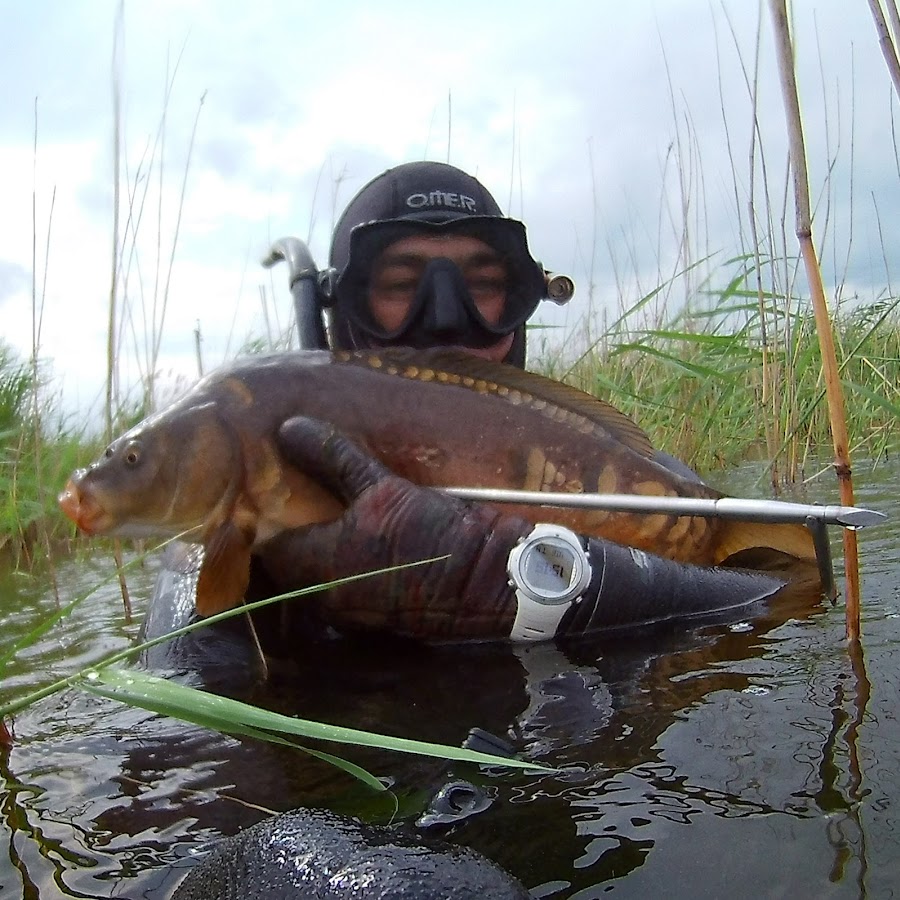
left=172, top=809, right=530, bottom=900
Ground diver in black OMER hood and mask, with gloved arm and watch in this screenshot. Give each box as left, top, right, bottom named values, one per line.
left=250, top=162, right=812, bottom=642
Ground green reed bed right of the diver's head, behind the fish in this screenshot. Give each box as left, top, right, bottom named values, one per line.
left=534, top=259, right=900, bottom=486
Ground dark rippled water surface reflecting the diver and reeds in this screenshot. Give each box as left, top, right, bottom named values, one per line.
left=0, top=462, right=900, bottom=900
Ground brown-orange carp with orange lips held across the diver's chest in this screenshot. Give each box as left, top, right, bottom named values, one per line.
left=59, top=348, right=815, bottom=616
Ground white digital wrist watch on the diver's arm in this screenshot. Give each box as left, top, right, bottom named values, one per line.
left=506, top=525, right=592, bottom=641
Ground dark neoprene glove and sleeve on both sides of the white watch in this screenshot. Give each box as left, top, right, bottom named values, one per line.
left=258, top=417, right=796, bottom=641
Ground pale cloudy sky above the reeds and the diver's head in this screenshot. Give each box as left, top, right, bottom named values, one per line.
left=0, top=0, right=900, bottom=418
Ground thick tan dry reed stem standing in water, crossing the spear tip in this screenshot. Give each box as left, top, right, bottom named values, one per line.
left=769, top=0, right=859, bottom=642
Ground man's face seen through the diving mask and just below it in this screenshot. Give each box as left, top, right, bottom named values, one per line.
left=369, top=234, right=513, bottom=361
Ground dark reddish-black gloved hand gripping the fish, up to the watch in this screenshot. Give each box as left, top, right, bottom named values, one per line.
left=258, top=417, right=533, bottom=641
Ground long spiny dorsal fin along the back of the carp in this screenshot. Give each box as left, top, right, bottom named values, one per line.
left=335, top=347, right=653, bottom=459
